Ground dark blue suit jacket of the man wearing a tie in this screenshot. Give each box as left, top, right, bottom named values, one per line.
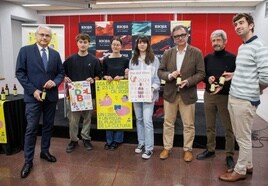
left=16, top=44, right=64, bottom=102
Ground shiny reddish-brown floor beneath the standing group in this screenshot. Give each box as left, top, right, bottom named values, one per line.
left=0, top=117, right=268, bottom=186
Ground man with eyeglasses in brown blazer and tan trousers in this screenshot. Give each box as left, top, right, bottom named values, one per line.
left=158, top=25, right=205, bottom=162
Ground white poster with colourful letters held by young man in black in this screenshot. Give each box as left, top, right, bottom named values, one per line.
left=68, top=81, right=93, bottom=112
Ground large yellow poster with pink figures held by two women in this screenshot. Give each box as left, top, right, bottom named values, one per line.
left=96, top=80, right=133, bottom=129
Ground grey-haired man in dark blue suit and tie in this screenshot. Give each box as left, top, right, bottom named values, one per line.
left=16, top=25, right=64, bottom=178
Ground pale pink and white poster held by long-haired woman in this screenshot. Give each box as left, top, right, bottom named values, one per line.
left=128, top=70, right=152, bottom=102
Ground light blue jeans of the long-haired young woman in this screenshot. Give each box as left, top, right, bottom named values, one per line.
left=133, top=102, right=154, bottom=150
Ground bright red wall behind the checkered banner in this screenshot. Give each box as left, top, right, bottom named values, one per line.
left=46, top=14, right=241, bottom=88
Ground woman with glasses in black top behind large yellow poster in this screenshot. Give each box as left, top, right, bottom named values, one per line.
left=103, top=37, right=129, bottom=150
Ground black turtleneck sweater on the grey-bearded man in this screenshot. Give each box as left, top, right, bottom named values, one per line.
left=204, top=50, right=236, bottom=95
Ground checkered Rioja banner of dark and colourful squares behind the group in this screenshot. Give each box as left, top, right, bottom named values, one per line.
left=79, top=21, right=191, bottom=56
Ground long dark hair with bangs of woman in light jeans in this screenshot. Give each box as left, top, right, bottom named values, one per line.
left=131, top=36, right=154, bottom=65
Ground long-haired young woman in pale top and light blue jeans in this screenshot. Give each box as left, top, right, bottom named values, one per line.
left=129, top=36, right=160, bottom=159
